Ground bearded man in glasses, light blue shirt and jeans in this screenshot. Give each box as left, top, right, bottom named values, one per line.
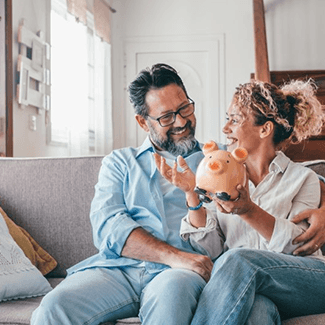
left=31, top=64, right=321, bottom=325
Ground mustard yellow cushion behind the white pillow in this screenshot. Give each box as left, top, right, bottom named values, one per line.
left=0, top=207, right=57, bottom=275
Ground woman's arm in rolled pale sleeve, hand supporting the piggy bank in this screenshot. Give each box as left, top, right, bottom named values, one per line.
left=216, top=166, right=320, bottom=254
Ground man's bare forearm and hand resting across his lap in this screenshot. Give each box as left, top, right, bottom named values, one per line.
left=121, top=227, right=213, bottom=282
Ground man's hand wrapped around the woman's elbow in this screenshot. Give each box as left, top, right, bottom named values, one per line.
left=292, top=181, right=325, bottom=256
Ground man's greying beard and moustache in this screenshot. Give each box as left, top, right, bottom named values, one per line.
left=148, top=121, right=196, bottom=157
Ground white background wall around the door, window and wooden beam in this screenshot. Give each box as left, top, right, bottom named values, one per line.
left=13, top=0, right=325, bottom=156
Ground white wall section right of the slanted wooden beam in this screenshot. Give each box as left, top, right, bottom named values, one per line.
left=264, top=0, right=325, bottom=70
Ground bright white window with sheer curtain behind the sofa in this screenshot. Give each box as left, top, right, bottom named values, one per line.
left=51, top=0, right=113, bottom=156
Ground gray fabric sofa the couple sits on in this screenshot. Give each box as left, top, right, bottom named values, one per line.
left=0, top=157, right=325, bottom=325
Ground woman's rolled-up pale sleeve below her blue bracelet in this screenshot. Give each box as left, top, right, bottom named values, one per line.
left=180, top=209, right=224, bottom=259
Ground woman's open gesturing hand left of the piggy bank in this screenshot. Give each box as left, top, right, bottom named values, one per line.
left=153, top=153, right=195, bottom=193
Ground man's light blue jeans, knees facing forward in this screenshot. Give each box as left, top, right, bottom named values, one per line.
left=31, top=267, right=206, bottom=325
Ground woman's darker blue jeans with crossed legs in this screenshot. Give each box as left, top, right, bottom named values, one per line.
left=192, top=249, right=325, bottom=325
